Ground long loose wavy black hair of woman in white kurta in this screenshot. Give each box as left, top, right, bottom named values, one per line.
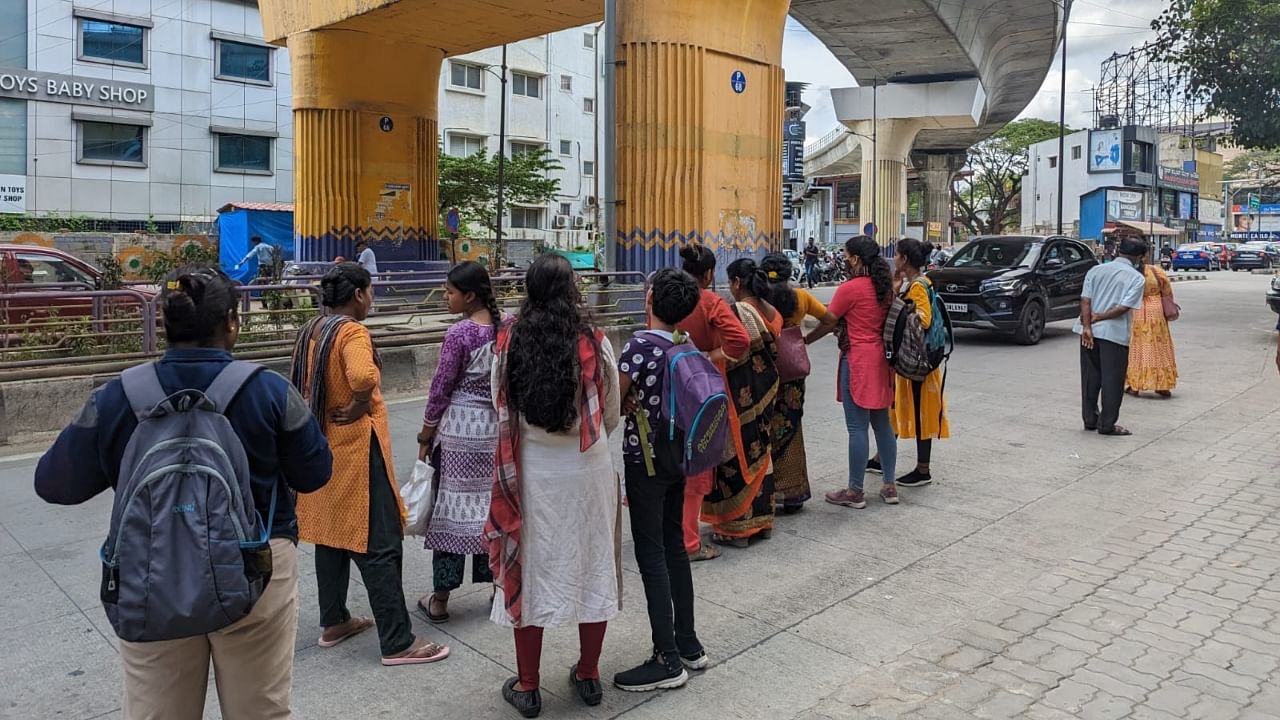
left=506, top=252, right=603, bottom=433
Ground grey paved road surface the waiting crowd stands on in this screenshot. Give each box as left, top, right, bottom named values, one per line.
left=0, top=273, right=1280, bottom=720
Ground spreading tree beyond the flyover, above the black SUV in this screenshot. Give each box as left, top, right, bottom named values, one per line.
left=955, top=118, right=1074, bottom=234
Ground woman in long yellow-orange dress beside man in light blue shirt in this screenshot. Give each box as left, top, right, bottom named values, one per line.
left=1125, top=263, right=1178, bottom=397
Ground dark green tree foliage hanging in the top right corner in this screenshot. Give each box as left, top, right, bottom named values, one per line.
left=1149, top=0, right=1280, bottom=147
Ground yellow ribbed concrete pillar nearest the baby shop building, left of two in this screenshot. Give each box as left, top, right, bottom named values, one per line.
left=288, top=29, right=444, bottom=261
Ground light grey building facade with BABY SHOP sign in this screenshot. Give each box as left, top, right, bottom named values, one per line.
left=0, top=0, right=293, bottom=223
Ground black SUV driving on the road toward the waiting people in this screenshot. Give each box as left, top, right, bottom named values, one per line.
left=929, top=236, right=1098, bottom=345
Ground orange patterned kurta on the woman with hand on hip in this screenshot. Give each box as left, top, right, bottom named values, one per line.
left=298, top=323, right=404, bottom=552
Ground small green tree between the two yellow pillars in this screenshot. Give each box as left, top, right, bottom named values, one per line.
left=439, top=149, right=563, bottom=266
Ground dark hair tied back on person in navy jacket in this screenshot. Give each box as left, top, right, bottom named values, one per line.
left=160, top=265, right=236, bottom=345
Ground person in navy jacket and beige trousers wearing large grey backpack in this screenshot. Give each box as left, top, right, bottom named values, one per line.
left=36, top=266, right=333, bottom=720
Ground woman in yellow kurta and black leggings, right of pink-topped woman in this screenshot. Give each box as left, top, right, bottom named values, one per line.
left=872, top=238, right=951, bottom=488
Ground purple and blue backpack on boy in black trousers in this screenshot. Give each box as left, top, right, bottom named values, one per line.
left=645, top=331, right=728, bottom=477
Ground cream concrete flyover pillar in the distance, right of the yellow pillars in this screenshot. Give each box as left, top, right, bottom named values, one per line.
left=849, top=118, right=924, bottom=246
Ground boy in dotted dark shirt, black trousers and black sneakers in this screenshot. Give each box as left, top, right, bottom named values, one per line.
left=613, top=268, right=708, bottom=692
